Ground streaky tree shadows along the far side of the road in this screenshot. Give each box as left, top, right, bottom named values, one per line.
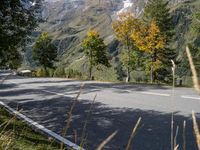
left=0, top=76, right=170, bottom=94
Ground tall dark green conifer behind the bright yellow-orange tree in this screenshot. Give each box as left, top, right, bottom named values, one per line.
left=143, top=0, right=176, bottom=80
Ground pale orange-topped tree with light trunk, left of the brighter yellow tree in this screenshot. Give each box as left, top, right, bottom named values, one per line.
left=112, top=12, right=139, bottom=82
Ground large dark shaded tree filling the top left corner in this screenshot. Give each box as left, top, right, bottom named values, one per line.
left=0, top=0, right=41, bottom=68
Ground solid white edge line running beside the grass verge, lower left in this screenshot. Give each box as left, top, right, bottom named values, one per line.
left=0, top=101, right=85, bottom=150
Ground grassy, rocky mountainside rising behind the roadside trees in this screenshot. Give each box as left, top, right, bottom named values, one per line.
left=23, top=0, right=200, bottom=80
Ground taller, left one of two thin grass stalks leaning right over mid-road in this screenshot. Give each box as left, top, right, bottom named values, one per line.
left=60, top=84, right=84, bottom=150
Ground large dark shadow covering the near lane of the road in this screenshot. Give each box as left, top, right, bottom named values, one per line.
left=6, top=97, right=197, bottom=150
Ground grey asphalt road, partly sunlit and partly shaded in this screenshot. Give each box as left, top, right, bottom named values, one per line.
left=0, top=71, right=200, bottom=150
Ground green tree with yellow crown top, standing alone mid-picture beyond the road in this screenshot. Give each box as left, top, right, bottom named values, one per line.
left=82, top=30, right=110, bottom=79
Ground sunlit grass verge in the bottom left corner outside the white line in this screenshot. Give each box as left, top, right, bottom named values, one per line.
left=0, top=107, right=59, bottom=150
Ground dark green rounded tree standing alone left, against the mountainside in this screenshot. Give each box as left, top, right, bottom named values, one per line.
left=32, top=32, right=57, bottom=70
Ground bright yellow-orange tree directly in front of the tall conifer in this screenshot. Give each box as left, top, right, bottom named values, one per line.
left=131, top=21, right=165, bottom=82
